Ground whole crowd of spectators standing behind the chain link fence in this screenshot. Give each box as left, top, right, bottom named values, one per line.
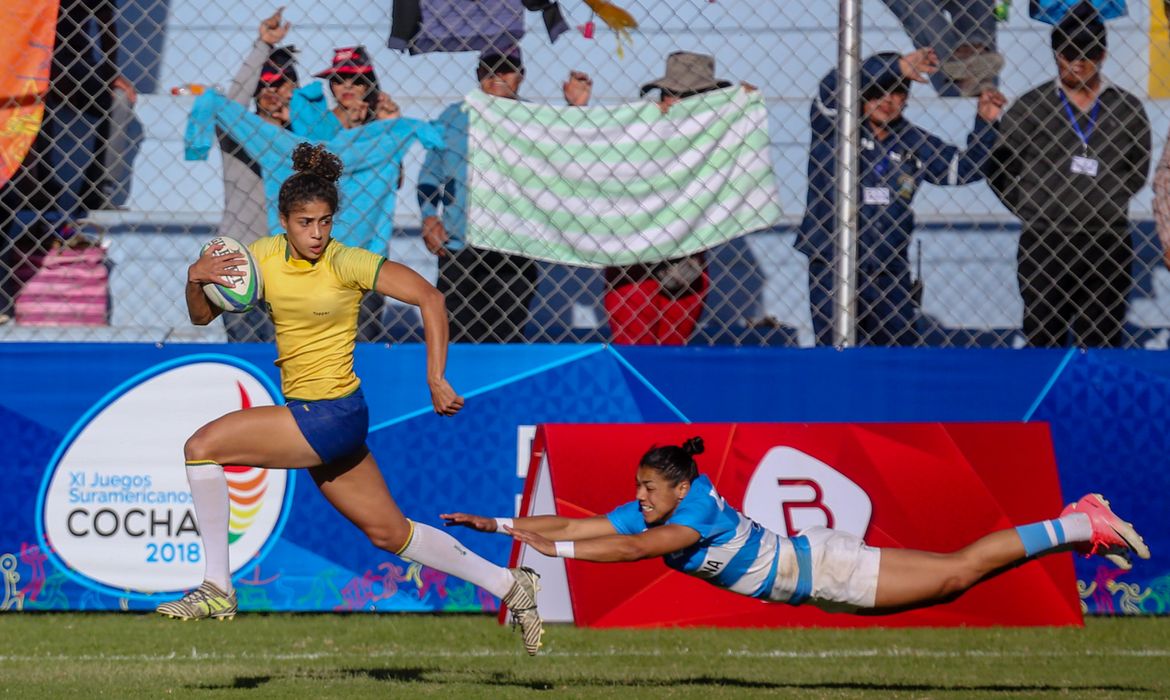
left=0, top=0, right=1170, bottom=346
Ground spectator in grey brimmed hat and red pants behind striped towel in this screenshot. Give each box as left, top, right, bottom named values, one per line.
left=605, top=52, right=731, bottom=345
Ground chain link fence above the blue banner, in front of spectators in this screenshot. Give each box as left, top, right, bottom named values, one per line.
left=0, top=0, right=1170, bottom=349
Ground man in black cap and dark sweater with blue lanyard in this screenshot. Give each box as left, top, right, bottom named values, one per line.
left=992, top=2, right=1150, bottom=348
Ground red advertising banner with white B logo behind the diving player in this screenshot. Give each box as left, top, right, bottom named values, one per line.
left=512, top=423, right=1082, bottom=627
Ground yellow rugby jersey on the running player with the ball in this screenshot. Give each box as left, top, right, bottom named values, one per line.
left=248, top=235, right=385, bottom=400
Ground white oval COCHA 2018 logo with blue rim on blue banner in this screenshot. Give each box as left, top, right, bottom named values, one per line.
left=37, top=362, right=294, bottom=596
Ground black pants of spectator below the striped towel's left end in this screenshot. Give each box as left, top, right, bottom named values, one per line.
left=439, top=247, right=537, bottom=343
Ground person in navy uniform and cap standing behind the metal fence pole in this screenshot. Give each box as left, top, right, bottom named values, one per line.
left=796, top=48, right=1006, bottom=345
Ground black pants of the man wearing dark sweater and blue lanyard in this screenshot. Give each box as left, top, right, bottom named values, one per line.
left=1017, top=227, right=1134, bottom=348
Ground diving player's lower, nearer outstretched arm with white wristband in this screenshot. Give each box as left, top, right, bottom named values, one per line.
left=507, top=524, right=698, bottom=562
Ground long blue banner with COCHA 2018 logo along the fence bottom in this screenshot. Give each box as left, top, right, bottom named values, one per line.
left=0, top=343, right=1170, bottom=613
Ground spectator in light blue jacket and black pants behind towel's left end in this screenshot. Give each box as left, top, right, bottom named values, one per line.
left=418, top=48, right=591, bottom=343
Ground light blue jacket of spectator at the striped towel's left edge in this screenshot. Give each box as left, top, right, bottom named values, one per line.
left=418, top=102, right=468, bottom=251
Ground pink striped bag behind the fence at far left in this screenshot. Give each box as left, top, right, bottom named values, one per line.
left=16, top=245, right=110, bottom=325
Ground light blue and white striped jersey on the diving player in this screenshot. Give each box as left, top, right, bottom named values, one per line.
left=606, top=475, right=780, bottom=598
